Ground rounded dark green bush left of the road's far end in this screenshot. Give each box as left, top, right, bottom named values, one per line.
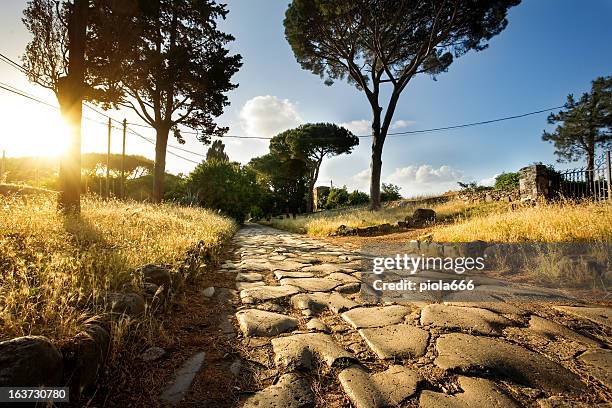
left=185, top=160, right=259, bottom=222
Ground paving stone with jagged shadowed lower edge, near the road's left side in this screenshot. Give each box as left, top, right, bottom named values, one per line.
left=272, top=333, right=353, bottom=371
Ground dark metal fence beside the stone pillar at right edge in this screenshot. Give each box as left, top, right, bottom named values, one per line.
left=552, top=151, right=612, bottom=201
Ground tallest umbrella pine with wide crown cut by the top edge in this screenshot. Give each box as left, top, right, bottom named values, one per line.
left=284, top=0, right=520, bottom=209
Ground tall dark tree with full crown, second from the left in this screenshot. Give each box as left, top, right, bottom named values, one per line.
left=122, top=0, right=242, bottom=202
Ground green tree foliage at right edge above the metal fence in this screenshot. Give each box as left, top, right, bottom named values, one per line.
left=542, top=76, right=612, bottom=169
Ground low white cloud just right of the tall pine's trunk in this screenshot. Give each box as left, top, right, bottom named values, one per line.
left=385, top=164, right=463, bottom=196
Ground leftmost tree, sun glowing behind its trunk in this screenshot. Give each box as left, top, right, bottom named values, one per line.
left=22, top=0, right=137, bottom=213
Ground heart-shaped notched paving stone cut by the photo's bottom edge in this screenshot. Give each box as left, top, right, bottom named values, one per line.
left=338, top=365, right=421, bottom=408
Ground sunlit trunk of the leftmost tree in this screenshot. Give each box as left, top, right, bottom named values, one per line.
left=57, top=0, right=89, bottom=214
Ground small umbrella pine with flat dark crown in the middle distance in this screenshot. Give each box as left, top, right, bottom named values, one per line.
left=270, top=123, right=359, bottom=212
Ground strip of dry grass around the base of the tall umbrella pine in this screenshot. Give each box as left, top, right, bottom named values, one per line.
left=268, top=200, right=508, bottom=236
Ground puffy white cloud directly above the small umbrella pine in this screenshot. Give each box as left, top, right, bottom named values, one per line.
left=240, top=95, right=304, bottom=137
